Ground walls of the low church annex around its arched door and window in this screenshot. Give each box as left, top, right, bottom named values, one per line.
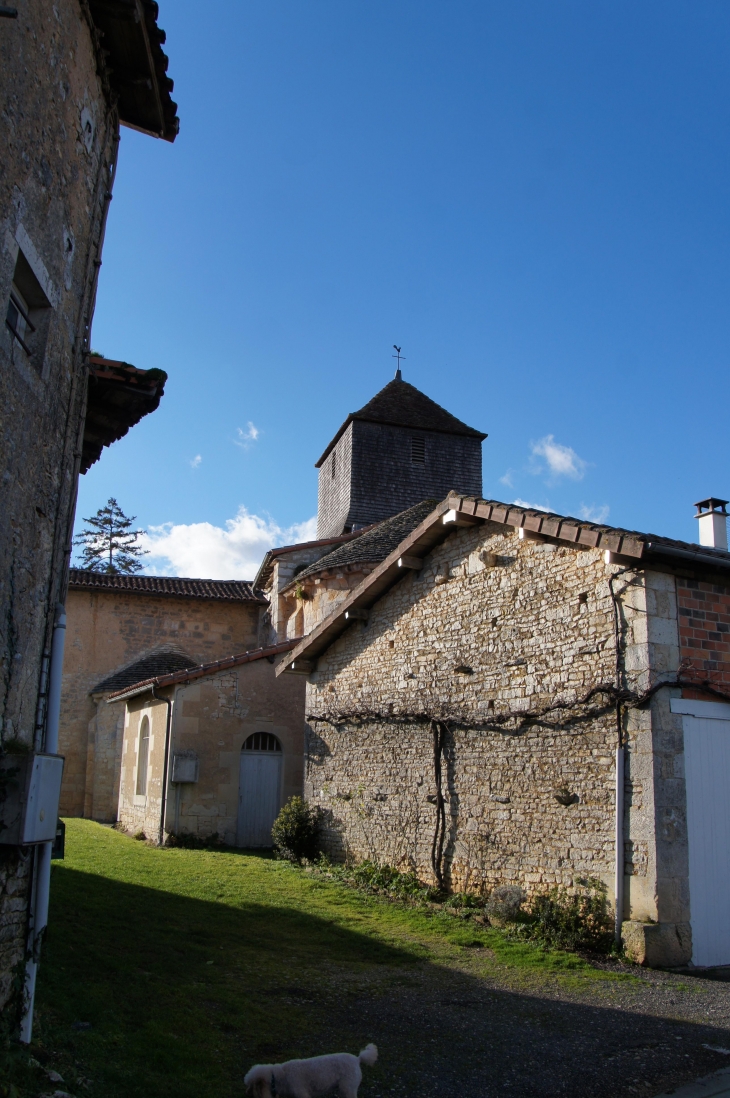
left=118, top=659, right=305, bottom=845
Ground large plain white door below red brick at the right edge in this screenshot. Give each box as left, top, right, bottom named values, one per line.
left=672, top=702, right=730, bottom=965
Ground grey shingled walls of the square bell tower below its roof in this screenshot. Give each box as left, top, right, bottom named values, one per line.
left=317, top=419, right=482, bottom=538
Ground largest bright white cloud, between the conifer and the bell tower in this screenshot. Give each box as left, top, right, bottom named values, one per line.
left=139, top=507, right=317, bottom=580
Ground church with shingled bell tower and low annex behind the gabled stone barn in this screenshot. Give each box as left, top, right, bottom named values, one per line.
left=60, top=370, right=486, bottom=845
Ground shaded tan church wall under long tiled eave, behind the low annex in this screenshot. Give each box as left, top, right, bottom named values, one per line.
left=59, top=589, right=262, bottom=821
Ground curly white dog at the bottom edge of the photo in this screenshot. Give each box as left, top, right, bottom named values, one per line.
left=244, top=1044, right=378, bottom=1098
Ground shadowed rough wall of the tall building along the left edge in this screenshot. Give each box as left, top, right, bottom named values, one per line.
left=0, top=0, right=119, bottom=1007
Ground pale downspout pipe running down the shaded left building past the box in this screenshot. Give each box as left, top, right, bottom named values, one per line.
left=20, top=603, right=66, bottom=1044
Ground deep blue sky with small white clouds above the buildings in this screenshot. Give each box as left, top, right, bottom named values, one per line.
left=78, top=0, right=730, bottom=578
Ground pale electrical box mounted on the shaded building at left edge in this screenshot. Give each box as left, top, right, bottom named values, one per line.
left=0, top=753, right=64, bottom=847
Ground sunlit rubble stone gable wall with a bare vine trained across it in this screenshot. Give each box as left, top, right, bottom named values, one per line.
left=305, top=523, right=676, bottom=919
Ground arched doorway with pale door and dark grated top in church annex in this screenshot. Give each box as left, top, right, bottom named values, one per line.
left=237, top=732, right=282, bottom=847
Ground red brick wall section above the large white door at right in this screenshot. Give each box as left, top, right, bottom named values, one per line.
left=676, top=578, right=730, bottom=691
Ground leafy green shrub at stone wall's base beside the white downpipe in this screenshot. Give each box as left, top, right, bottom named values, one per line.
left=515, top=877, right=614, bottom=953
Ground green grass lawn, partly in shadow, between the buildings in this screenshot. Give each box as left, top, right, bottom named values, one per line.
left=7, top=819, right=631, bottom=1098
